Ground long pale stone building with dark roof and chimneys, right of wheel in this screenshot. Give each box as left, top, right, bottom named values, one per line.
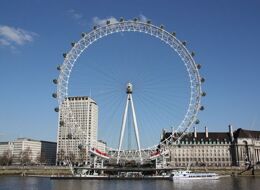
left=161, top=126, right=260, bottom=167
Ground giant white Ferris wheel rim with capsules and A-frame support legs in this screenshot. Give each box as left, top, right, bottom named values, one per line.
left=53, top=18, right=206, bottom=163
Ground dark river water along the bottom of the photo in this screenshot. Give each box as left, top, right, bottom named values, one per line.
left=0, top=176, right=260, bottom=190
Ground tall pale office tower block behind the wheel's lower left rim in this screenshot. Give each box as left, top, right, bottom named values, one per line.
left=57, top=96, right=98, bottom=164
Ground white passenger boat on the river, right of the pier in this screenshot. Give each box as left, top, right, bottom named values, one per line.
left=170, top=170, right=220, bottom=180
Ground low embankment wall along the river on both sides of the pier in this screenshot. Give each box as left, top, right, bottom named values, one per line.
left=0, top=166, right=260, bottom=177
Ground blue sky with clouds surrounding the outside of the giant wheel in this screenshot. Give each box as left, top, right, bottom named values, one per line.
left=0, top=0, right=260, bottom=145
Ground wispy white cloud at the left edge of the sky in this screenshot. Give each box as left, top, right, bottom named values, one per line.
left=0, top=25, right=38, bottom=47
